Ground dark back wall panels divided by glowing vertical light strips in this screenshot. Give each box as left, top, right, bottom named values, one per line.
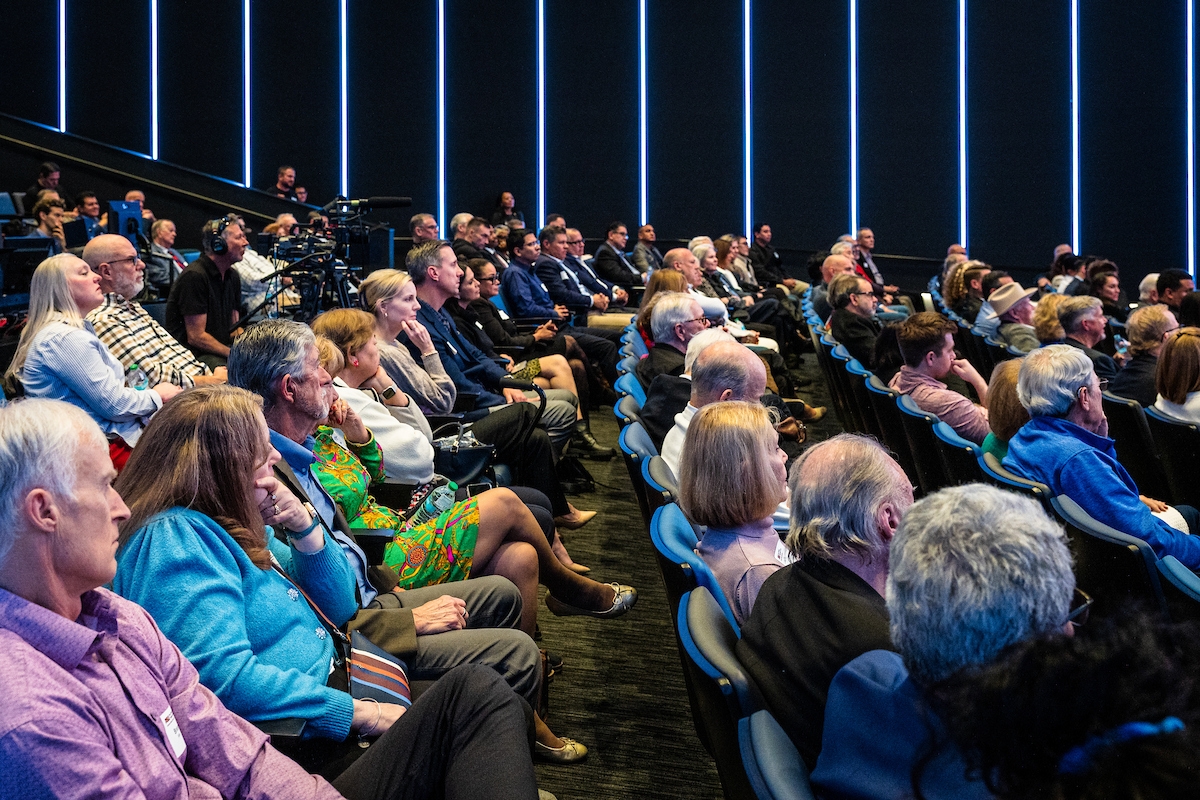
left=0, top=0, right=1187, bottom=281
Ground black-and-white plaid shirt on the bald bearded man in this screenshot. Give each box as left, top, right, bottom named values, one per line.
left=88, top=293, right=210, bottom=389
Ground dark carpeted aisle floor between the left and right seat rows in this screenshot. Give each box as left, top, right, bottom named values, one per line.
left=538, top=354, right=841, bottom=800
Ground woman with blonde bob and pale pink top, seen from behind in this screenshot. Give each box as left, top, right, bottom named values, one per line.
left=679, top=401, right=787, bottom=625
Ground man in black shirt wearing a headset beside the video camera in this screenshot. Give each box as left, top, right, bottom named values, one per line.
left=167, top=217, right=248, bottom=369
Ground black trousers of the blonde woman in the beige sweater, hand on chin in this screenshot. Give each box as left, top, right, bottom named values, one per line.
left=470, top=403, right=569, bottom=517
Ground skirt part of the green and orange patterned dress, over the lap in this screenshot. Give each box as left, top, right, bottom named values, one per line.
left=384, top=498, right=479, bottom=589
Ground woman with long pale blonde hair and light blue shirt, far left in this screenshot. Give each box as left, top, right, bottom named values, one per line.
left=5, top=253, right=180, bottom=469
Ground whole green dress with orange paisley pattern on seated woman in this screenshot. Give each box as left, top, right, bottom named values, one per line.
left=313, top=425, right=479, bottom=589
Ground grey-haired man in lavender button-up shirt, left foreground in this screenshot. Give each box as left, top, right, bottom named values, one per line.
left=0, top=399, right=535, bottom=800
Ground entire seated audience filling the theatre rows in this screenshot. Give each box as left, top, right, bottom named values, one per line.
left=0, top=183, right=1200, bottom=798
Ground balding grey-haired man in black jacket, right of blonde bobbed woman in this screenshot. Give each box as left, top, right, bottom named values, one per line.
left=737, top=434, right=912, bottom=769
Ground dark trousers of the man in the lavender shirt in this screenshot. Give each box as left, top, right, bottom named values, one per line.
left=321, top=664, right=538, bottom=800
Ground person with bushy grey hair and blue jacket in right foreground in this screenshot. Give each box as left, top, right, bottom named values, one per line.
left=812, top=483, right=1086, bottom=800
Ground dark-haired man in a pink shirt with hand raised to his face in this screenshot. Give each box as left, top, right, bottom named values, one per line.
left=888, top=311, right=989, bottom=444
